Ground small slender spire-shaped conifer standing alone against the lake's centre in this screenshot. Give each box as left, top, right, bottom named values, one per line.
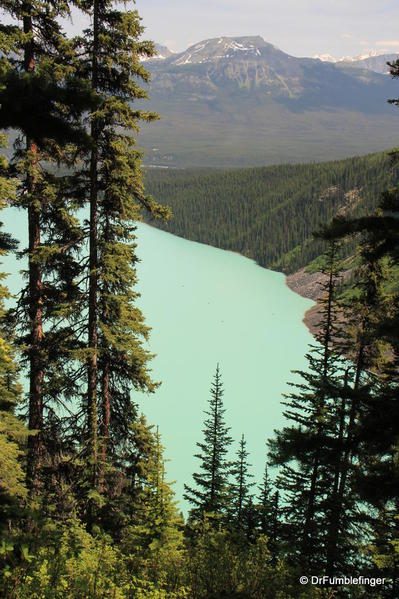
left=184, top=364, right=232, bottom=519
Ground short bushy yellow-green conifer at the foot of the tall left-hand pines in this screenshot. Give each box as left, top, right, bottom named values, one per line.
left=106, top=415, right=183, bottom=582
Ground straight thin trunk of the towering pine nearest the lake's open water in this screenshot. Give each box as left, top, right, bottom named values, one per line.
left=87, top=1, right=99, bottom=486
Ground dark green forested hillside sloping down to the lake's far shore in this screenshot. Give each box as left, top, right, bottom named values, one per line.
left=146, top=153, right=397, bottom=272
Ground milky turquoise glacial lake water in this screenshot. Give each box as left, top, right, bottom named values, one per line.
left=2, top=210, right=313, bottom=511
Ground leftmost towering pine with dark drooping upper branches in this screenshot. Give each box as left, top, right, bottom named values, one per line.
left=0, top=0, right=91, bottom=490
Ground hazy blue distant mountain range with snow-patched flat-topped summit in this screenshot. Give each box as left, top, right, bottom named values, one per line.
left=141, top=36, right=399, bottom=167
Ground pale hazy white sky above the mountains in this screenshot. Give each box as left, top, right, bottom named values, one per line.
left=132, top=0, right=399, bottom=57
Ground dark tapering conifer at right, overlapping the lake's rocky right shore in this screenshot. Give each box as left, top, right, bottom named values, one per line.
left=270, top=241, right=350, bottom=566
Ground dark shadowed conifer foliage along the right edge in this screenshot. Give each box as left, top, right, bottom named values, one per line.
left=316, top=146, right=399, bottom=597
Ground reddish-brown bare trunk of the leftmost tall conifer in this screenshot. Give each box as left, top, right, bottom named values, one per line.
left=23, top=3, right=43, bottom=492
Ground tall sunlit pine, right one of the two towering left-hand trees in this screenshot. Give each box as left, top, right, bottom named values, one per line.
left=76, top=0, right=168, bottom=491
